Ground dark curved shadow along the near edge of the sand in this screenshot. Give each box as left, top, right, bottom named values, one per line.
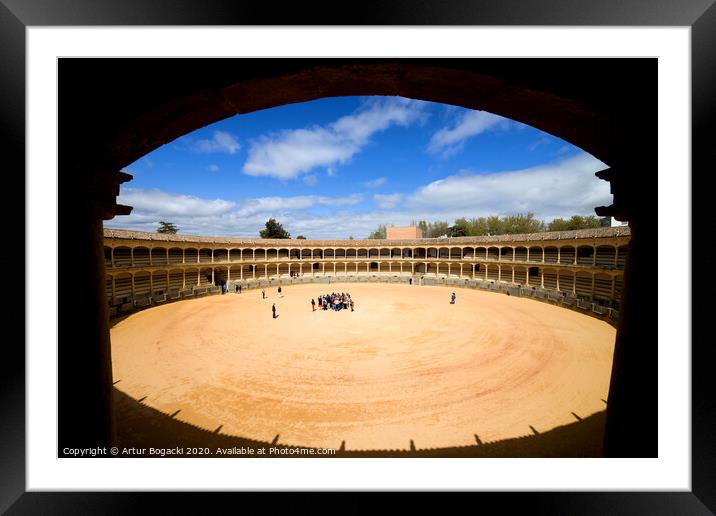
left=114, top=388, right=606, bottom=458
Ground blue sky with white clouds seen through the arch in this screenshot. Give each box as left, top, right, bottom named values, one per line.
left=105, top=97, right=612, bottom=238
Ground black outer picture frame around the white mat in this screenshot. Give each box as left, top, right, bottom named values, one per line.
left=0, top=0, right=716, bottom=514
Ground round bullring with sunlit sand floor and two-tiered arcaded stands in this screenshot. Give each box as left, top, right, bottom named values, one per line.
left=105, top=228, right=629, bottom=450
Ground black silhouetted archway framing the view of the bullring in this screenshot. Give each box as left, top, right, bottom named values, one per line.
left=58, top=58, right=657, bottom=457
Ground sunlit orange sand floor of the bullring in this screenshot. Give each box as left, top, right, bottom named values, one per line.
left=111, top=283, right=616, bottom=450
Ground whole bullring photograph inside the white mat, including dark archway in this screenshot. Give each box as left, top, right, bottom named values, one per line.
left=58, top=58, right=657, bottom=458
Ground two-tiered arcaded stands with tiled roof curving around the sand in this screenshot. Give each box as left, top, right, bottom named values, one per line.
left=104, top=227, right=631, bottom=321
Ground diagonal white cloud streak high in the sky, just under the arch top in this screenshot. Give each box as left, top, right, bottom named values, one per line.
left=243, top=97, right=425, bottom=179
